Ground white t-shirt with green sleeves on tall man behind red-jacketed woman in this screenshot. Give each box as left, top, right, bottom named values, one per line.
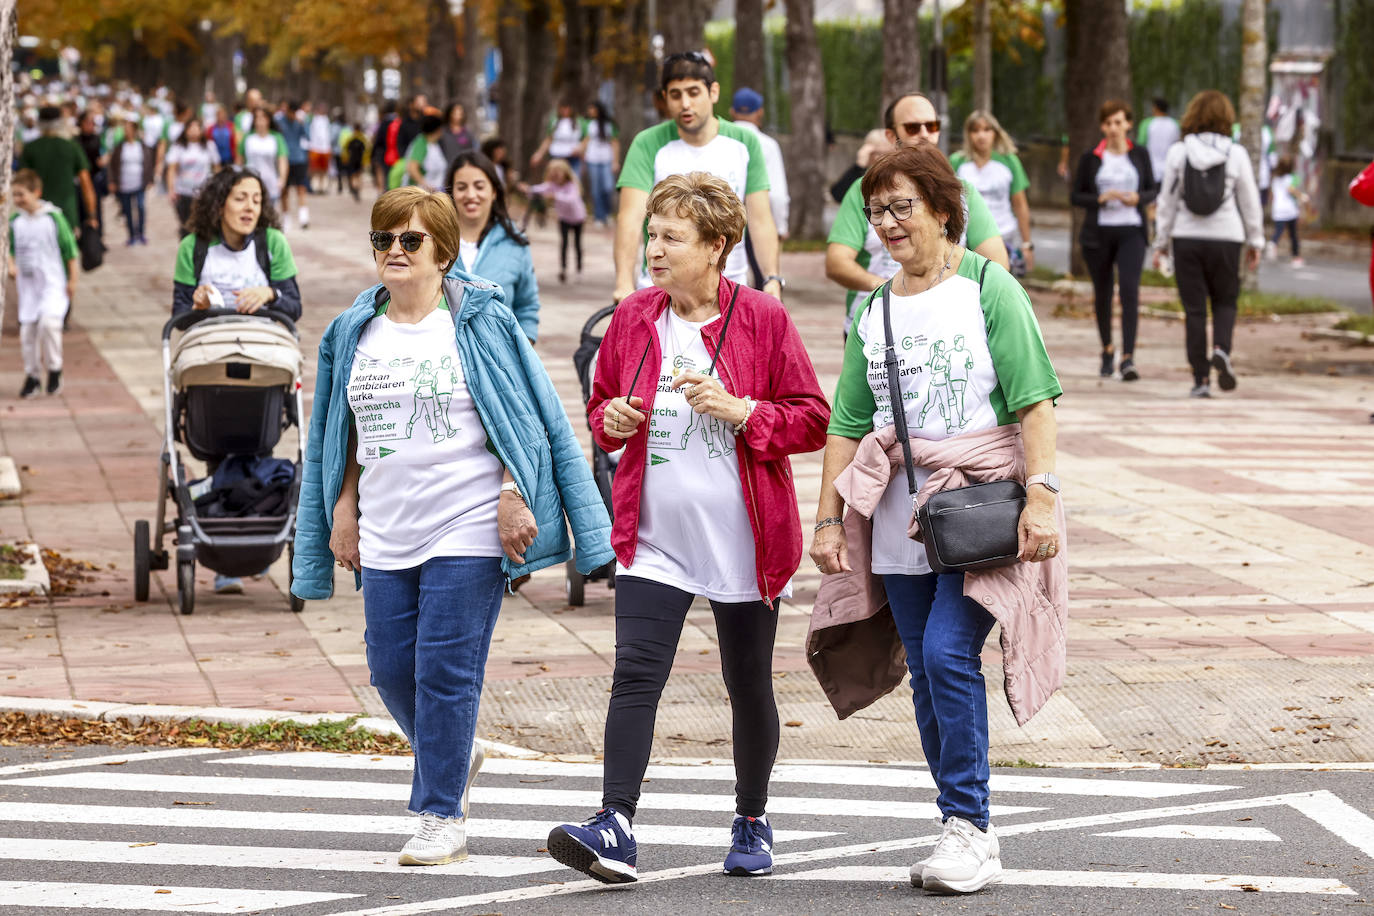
left=616, top=118, right=769, bottom=288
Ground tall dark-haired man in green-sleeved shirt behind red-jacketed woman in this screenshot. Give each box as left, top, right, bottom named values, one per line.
left=616, top=51, right=782, bottom=302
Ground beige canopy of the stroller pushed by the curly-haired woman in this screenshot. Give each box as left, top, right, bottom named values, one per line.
left=172, top=314, right=301, bottom=391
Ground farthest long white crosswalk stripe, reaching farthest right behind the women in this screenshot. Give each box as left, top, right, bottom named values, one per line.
left=218, top=751, right=1237, bottom=798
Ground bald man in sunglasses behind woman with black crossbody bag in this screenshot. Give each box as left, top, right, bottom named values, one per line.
left=826, top=92, right=1011, bottom=334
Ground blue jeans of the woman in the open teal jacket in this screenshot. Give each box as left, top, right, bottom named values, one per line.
left=363, top=556, right=506, bottom=817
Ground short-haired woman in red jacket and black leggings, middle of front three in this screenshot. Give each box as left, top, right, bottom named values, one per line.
left=548, top=172, right=830, bottom=883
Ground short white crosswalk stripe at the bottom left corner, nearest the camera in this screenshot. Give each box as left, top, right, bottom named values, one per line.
left=0, top=882, right=363, bottom=913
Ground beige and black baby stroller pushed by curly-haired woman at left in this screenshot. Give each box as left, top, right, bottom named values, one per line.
left=133, top=309, right=305, bottom=614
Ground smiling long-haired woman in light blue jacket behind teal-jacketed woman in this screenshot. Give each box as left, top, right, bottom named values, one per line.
left=444, top=150, right=539, bottom=343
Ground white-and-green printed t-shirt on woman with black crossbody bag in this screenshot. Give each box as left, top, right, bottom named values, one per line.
left=829, top=251, right=1062, bottom=575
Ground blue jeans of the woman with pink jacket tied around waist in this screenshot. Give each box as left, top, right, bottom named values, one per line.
left=882, top=573, right=995, bottom=829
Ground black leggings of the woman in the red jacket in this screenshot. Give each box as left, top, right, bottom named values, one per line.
left=602, top=575, right=778, bottom=817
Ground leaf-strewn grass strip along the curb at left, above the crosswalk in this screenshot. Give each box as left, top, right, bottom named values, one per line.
left=0, top=713, right=411, bottom=754
